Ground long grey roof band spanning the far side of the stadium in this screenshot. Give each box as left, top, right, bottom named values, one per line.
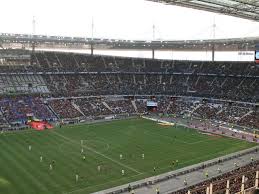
left=0, top=33, right=259, bottom=51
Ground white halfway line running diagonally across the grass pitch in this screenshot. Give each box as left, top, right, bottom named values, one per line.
left=52, top=130, right=142, bottom=174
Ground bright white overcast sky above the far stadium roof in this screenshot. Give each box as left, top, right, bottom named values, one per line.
left=0, top=0, right=259, bottom=40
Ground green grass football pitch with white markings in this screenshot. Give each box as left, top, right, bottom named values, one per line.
left=0, top=119, right=255, bottom=194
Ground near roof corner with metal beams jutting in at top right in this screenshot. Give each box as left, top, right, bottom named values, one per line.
left=149, top=0, right=259, bottom=21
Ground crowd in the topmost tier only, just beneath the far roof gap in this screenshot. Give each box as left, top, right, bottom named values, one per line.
left=29, top=52, right=259, bottom=75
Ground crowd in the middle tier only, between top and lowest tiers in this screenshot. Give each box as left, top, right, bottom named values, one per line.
left=33, top=73, right=259, bottom=102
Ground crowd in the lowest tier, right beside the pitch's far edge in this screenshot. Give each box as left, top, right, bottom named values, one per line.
left=0, top=96, right=259, bottom=129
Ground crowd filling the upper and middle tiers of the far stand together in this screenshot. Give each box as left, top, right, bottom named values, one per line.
left=1, top=52, right=259, bottom=102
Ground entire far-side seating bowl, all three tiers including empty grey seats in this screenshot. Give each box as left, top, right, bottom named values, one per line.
left=0, top=52, right=259, bottom=127
